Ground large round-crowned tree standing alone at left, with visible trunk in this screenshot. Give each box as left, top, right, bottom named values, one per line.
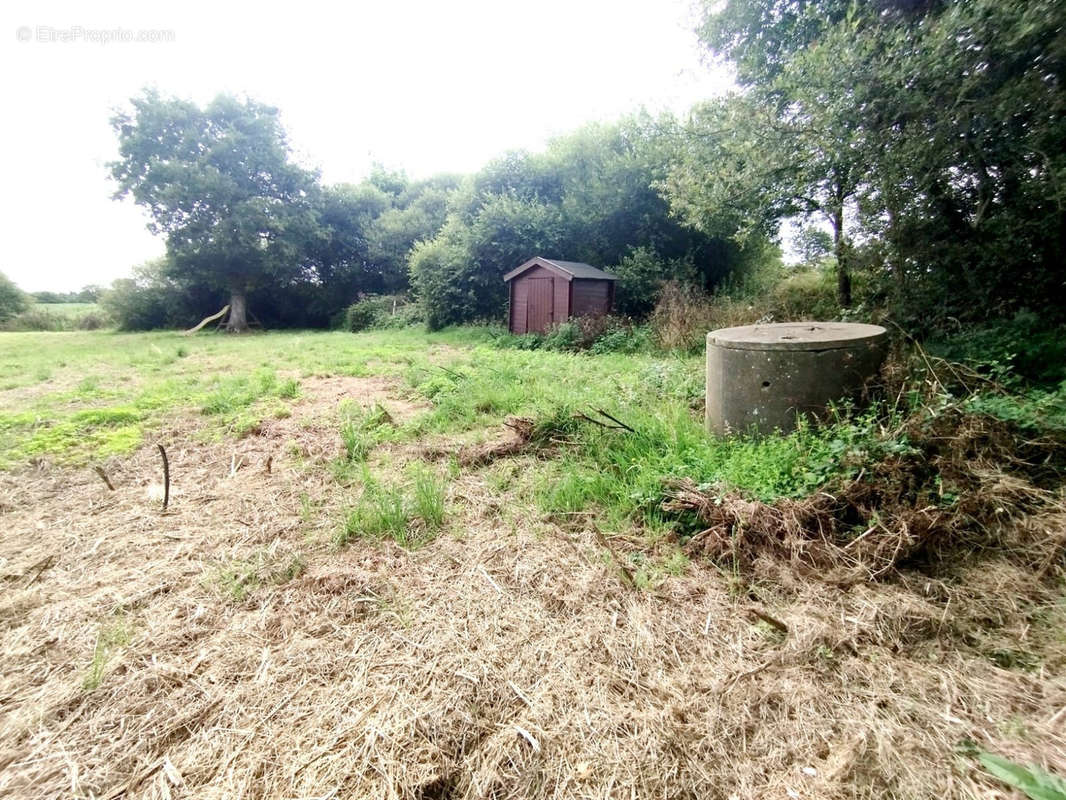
left=110, top=91, right=322, bottom=332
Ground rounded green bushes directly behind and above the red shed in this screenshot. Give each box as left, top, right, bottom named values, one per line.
left=410, top=115, right=755, bottom=330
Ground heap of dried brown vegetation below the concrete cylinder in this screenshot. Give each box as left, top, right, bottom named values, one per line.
left=664, top=407, right=1066, bottom=582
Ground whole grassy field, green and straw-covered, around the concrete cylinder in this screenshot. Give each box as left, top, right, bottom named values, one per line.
left=0, top=329, right=1066, bottom=798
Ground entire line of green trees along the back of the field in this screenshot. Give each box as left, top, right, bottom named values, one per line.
left=101, top=0, right=1066, bottom=331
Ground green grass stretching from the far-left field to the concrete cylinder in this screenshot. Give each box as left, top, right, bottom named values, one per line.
left=0, top=327, right=861, bottom=533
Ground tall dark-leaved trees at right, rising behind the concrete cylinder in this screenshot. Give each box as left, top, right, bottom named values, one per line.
left=665, top=0, right=1066, bottom=327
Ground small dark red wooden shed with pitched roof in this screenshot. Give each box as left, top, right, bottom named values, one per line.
left=503, top=256, right=618, bottom=334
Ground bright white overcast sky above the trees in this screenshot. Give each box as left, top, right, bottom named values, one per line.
left=0, top=0, right=730, bottom=291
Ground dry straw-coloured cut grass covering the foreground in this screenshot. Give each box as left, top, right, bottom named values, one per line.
left=0, top=379, right=1066, bottom=799
